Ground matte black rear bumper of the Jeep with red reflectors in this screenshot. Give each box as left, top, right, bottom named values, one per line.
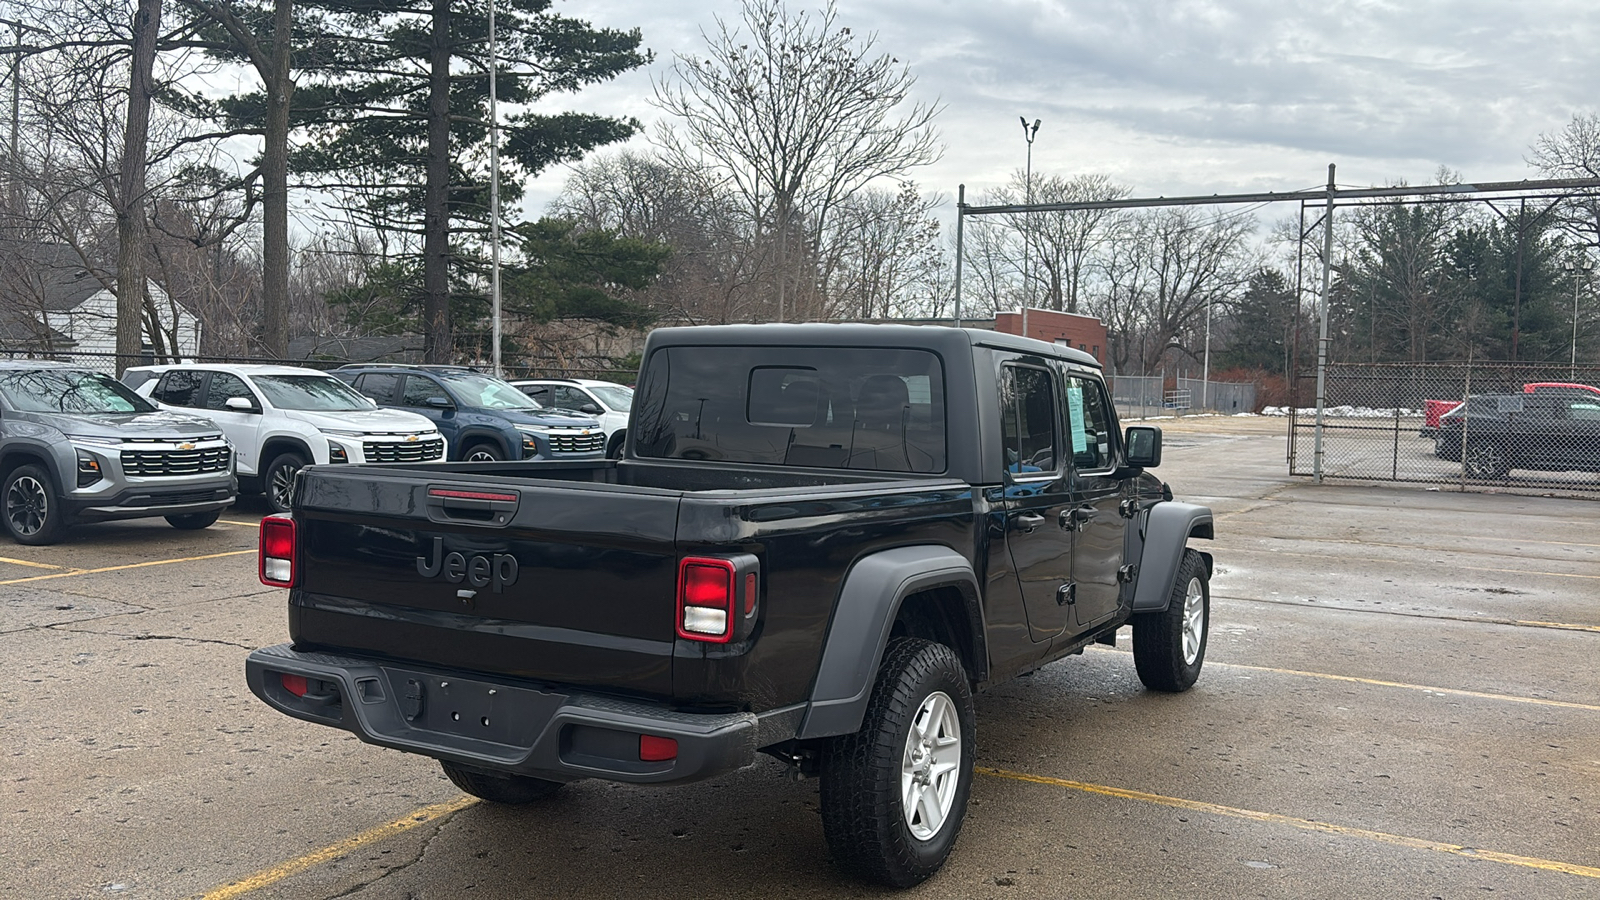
left=245, top=644, right=803, bottom=785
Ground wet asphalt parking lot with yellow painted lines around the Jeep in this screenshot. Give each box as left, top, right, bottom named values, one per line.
left=0, top=420, right=1600, bottom=900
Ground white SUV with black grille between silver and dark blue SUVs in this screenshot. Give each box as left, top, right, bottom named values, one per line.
left=122, top=364, right=446, bottom=512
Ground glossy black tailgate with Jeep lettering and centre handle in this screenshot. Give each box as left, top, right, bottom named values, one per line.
left=290, top=466, right=680, bottom=698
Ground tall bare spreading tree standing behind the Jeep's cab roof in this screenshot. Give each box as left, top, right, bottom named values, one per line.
left=654, top=0, right=942, bottom=320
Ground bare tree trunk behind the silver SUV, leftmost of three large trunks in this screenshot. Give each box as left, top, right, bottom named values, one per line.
left=115, top=0, right=162, bottom=376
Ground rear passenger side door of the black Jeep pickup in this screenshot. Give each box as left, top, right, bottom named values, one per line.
left=1000, top=364, right=1075, bottom=642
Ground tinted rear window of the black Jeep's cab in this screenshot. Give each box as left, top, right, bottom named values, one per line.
left=635, top=348, right=946, bottom=472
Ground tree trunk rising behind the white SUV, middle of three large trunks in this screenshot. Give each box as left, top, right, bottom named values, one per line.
left=261, top=0, right=294, bottom=359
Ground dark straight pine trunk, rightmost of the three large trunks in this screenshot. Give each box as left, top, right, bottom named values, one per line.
left=422, top=0, right=453, bottom=364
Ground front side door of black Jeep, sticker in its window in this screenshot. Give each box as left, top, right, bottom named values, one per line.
left=1062, top=373, right=1133, bottom=628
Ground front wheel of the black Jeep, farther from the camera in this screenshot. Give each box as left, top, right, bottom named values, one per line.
left=1133, top=549, right=1211, bottom=693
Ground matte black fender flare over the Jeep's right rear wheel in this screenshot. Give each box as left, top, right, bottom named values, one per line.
left=795, top=544, right=987, bottom=738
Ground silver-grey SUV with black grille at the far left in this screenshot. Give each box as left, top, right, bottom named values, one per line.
left=0, top=360, right=238, bottom=544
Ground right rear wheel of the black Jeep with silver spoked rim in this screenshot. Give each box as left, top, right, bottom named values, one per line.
left=821, top=637, right=976, bottom=887
